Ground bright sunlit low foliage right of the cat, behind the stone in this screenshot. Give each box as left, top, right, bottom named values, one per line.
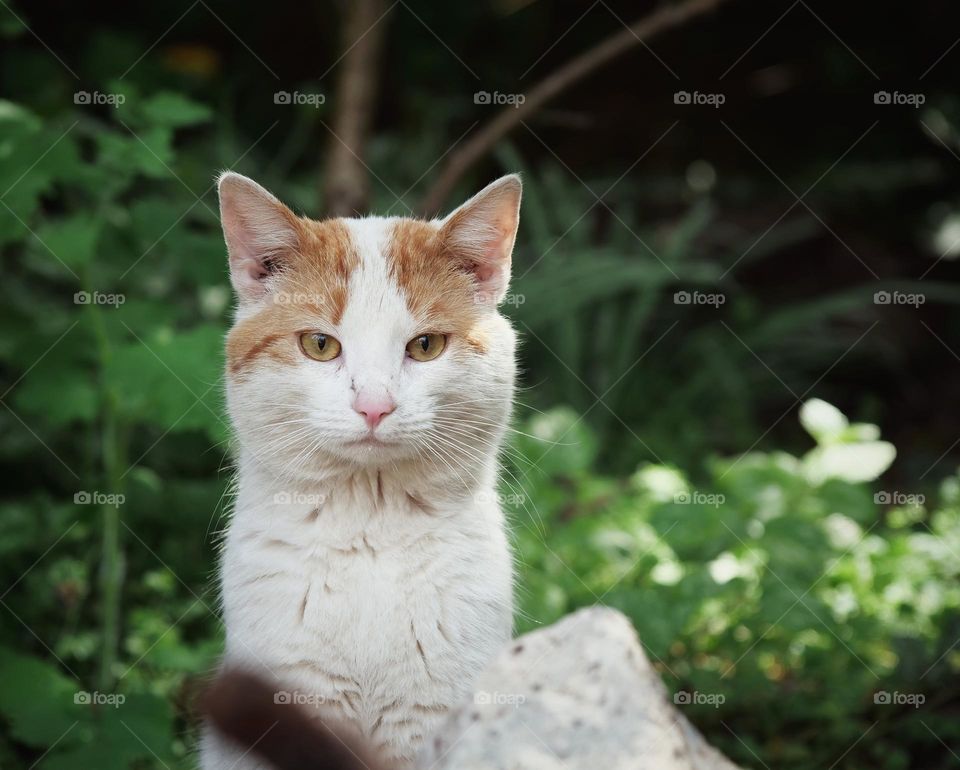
left=504, top=401, right=960, bottom=768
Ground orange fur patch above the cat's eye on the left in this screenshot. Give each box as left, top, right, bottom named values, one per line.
left=227, top=217, right=360, bottom=374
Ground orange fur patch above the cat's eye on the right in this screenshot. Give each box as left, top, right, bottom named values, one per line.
left=386, top=219, right=487, bottom=353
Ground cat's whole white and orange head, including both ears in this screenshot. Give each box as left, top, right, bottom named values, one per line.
left=219, top=173, right=521, bottom=478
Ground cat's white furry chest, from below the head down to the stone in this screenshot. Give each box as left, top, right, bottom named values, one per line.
left=222, top=486, right=512, bottom=751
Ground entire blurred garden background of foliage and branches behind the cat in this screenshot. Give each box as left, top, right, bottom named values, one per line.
left=0, top=0, right=960, bottom=770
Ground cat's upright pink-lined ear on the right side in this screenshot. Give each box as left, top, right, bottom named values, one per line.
left=440, top=174, right=523, bottom=304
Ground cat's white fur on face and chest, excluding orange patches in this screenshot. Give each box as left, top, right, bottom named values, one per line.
left=202, top=189, right=515, bottom=770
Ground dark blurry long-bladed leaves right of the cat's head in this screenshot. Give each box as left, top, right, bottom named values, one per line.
left=500, top=141, right=960, bottom=473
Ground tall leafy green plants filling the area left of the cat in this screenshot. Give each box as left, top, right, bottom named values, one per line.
left=0, top=76, right=229, bottom=770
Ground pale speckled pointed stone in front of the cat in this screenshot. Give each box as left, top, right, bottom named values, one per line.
left=420, top=607, right=737, bottom=770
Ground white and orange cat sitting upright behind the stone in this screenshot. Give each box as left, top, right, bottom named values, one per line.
left=201, top=172, right=522, bottom=770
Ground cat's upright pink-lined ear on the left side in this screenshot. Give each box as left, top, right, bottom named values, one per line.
left=217, top=171, right=299, bottom=302
